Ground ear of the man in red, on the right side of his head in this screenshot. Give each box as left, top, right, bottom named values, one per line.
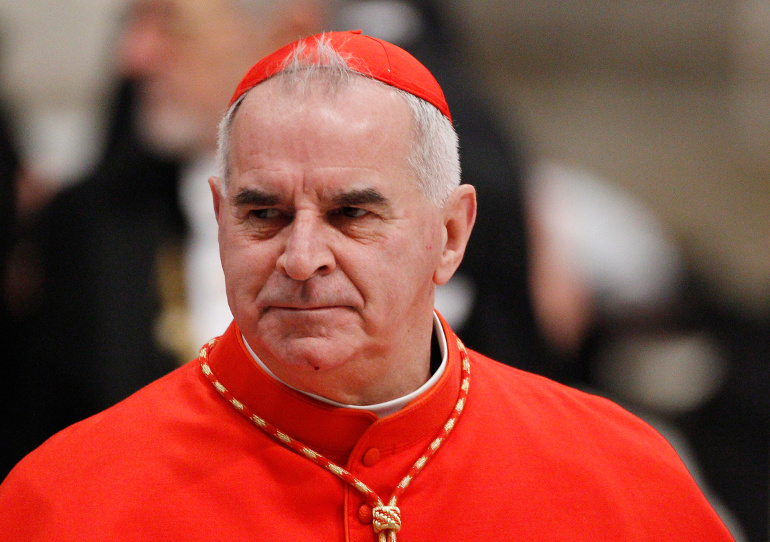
left=433, top=184, right=476, bottom=285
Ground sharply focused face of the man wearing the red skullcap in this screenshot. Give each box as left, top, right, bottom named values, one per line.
left=212, top=76, right=446, bottom=404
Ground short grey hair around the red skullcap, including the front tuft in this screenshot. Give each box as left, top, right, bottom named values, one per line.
left=217, top=36, right=460, bottom=207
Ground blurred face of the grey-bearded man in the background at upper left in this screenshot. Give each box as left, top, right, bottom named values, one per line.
left=118, top=0, right=273, bottom=158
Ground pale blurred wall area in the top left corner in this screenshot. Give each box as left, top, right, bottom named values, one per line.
left=0, top=0, right=126, bottom=182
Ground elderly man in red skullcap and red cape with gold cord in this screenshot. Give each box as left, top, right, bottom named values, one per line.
left=0, top=32, right=731, bottom=542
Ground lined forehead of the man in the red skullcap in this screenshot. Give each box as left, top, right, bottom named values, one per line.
left=226, top=76, right=412, bottom=185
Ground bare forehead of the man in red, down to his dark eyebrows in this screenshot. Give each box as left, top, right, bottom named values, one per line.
left=225, top=75, right=413, bottom=200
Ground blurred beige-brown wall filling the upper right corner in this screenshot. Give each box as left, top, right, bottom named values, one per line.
left=444, top=0, right=770, bottom=311
